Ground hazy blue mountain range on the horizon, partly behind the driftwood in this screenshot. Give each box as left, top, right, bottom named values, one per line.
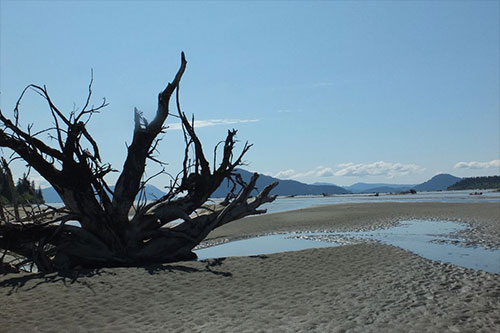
left=42, top=169, right=461, bottom=203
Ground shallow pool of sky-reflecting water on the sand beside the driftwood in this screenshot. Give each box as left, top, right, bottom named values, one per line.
left=195, top=220, right=500, bottom=273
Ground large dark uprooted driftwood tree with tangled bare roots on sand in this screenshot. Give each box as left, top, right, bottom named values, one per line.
left=0, top=53, right=276, bottom=271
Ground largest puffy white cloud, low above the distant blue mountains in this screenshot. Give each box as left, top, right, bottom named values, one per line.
left=334, top=161, right=425, bottom=178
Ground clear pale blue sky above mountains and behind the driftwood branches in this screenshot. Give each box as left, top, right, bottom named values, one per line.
left=0, top=0, right=500, bottom=186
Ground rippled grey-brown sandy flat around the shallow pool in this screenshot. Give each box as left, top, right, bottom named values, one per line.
left=0, top=204, right=500, bottom=332
